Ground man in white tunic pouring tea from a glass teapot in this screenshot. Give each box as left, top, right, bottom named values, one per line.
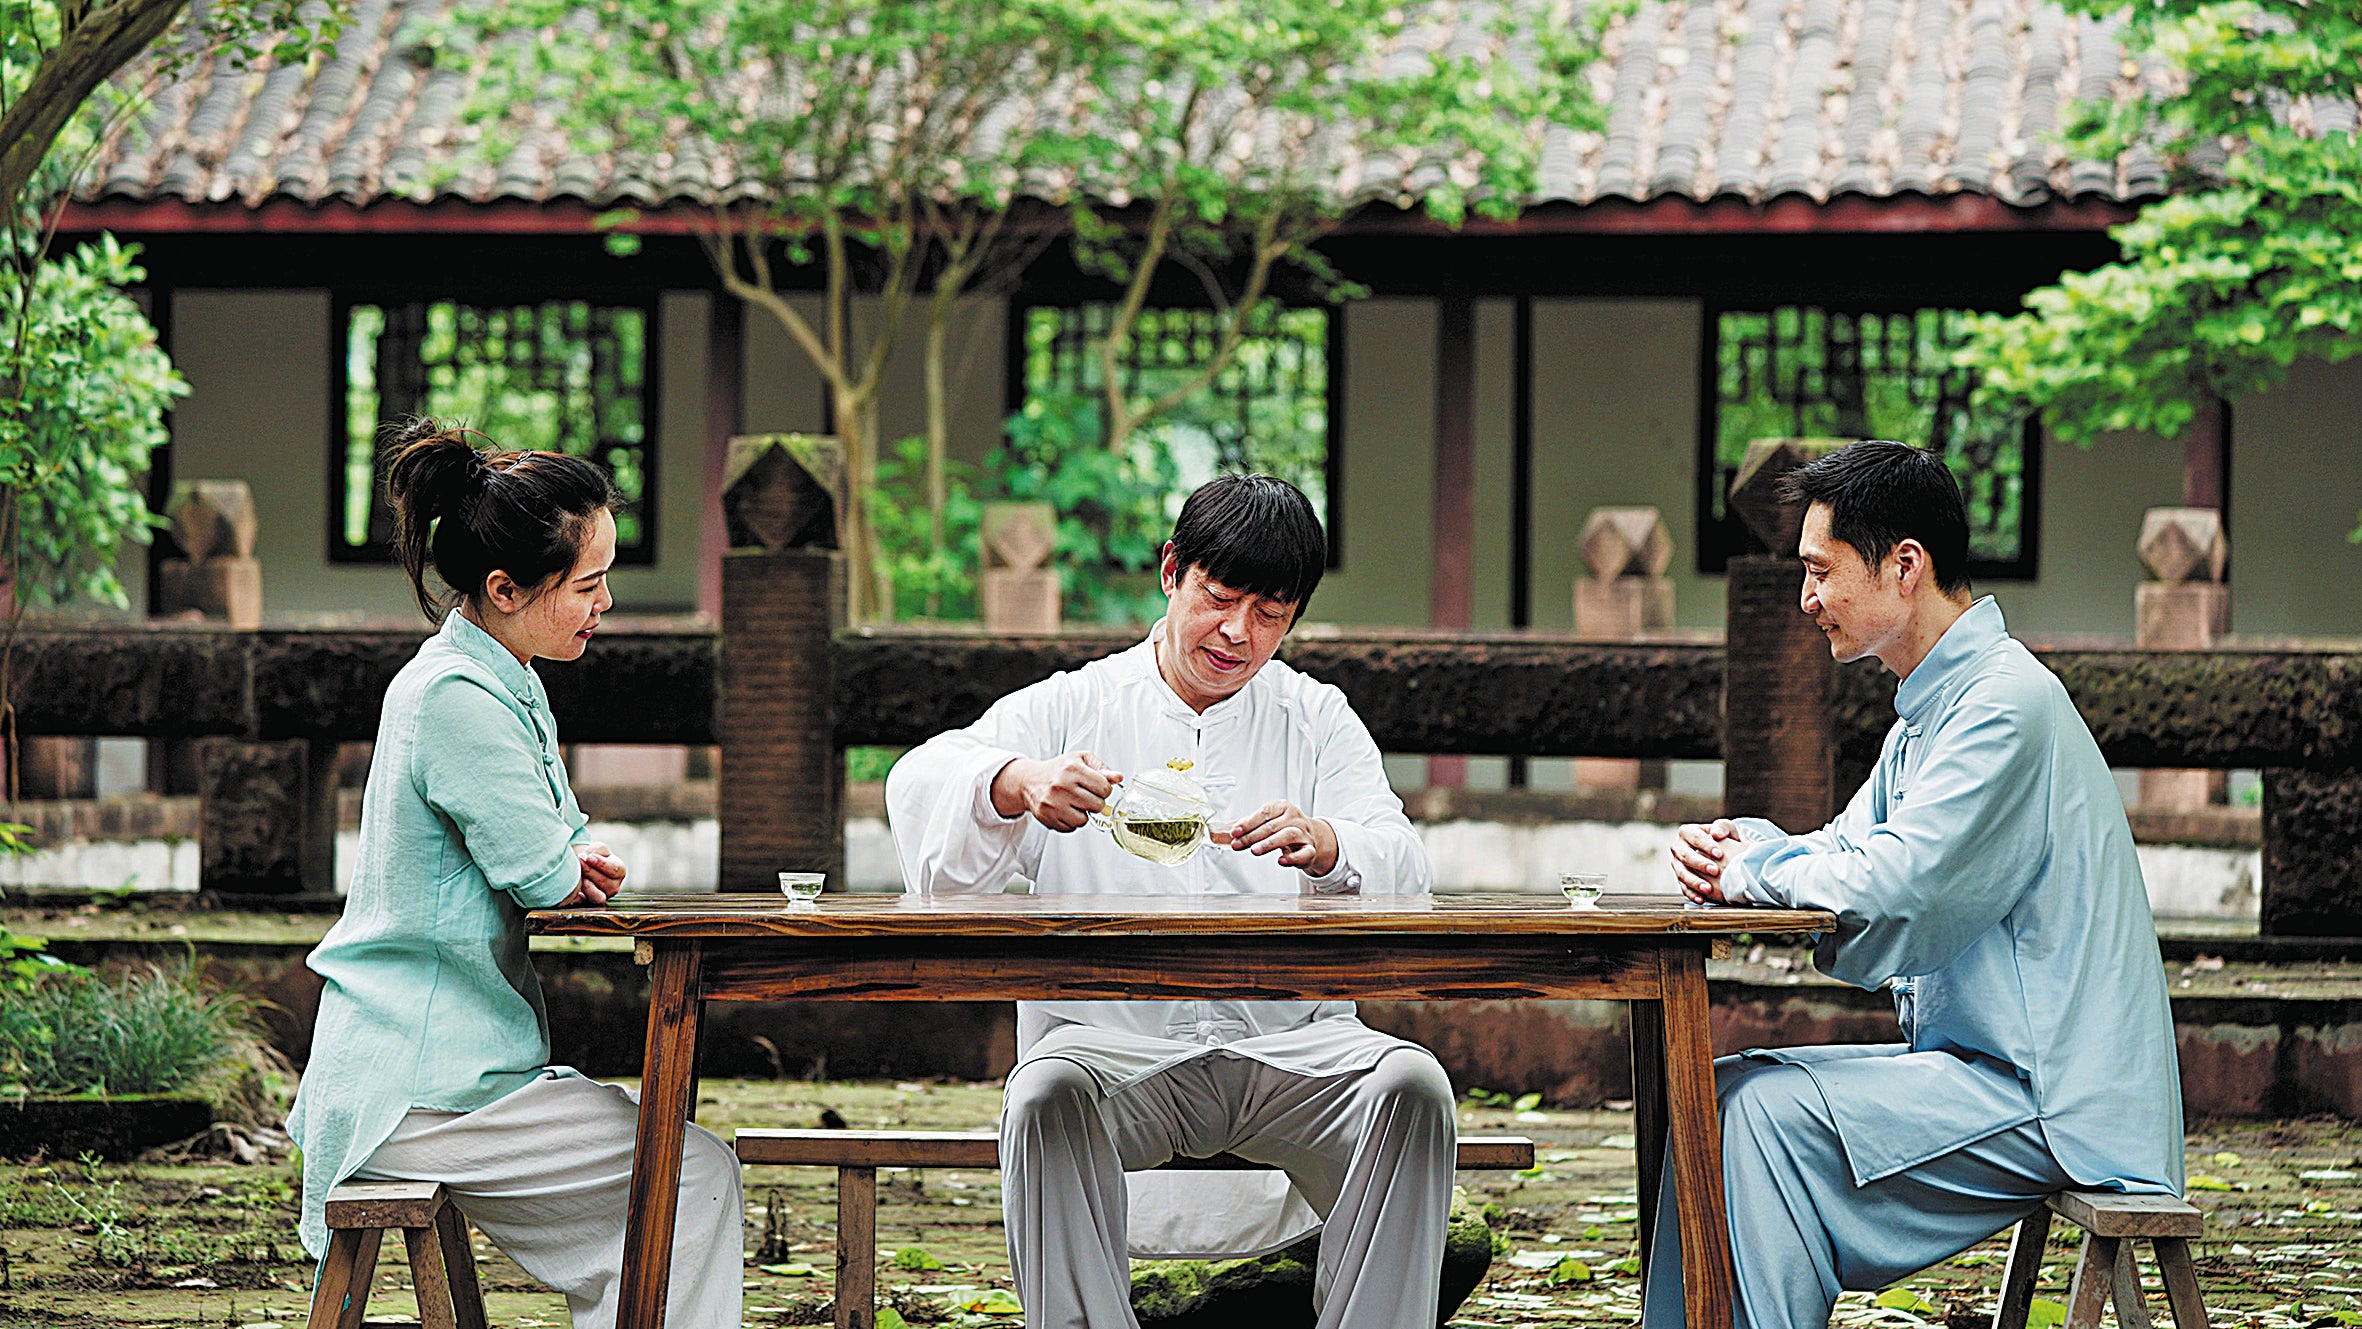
left=886, top=477, right=1457, bottom=1329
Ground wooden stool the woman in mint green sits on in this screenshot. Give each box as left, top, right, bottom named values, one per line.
left=312, top=1180, right=487, bottom=1329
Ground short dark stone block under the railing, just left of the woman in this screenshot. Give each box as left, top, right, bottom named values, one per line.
left=196, top=739, right=335, bottom=895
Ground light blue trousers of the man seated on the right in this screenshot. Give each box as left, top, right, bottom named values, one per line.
left=1642, top=1058, right=2074, bottom=1329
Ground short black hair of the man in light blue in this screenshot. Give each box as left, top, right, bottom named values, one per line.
left=1779, top=439, right=1968, bottom=595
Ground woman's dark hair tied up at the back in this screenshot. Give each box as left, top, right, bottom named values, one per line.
left=385, top=418, right=616, bottom=618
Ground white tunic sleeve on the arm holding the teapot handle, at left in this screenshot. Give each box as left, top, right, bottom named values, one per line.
left=886, top=673, right=1072, bottom=895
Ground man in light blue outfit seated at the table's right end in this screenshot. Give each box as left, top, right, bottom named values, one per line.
left=1644, top=441, right=2182, bottom=1329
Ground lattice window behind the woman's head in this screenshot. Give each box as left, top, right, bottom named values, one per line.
left=328, top=300, right=657, bottom=564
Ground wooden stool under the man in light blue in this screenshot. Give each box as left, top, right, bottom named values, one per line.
left=1994, top=1190, right=2206, bottom=1329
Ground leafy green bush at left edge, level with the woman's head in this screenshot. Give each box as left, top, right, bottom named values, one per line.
left=0, top=236, right=189, bottom=609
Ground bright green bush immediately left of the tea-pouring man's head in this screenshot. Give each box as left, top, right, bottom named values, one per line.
left=985, top=392, right=1181, bottom=623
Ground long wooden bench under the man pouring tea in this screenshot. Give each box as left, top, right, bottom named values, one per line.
left=735, top=1131, right=1533, bottom=1329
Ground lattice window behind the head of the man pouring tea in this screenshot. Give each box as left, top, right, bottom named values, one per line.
left=1023, top=302, right=1339, bottom=557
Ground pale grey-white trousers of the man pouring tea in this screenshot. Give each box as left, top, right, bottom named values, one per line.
left=1001, top=1048, right=1457, bottom=1329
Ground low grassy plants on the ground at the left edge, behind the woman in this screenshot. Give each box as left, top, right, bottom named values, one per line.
left=0, top=968, right=253, bottom=1093
